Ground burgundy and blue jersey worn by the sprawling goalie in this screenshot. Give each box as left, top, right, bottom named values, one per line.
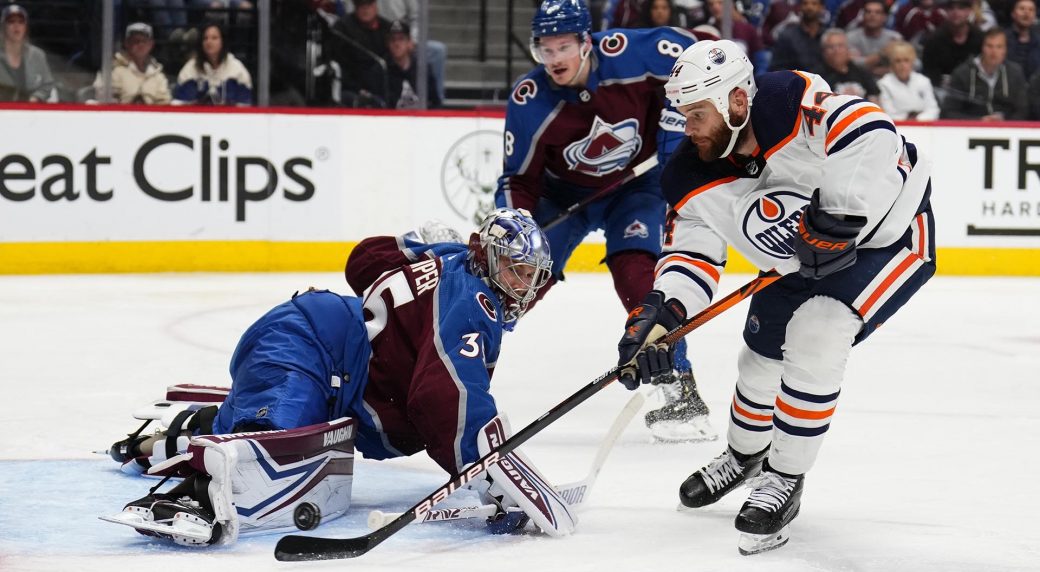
left=346, top=237, right=503, bottom=474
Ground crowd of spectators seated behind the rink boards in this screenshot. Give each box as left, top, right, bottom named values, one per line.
left=0, top=0, right=1040, bottom=121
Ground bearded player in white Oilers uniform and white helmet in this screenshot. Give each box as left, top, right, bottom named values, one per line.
left=619, top=41, right=935, bottom=554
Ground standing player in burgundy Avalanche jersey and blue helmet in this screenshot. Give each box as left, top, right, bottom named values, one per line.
left=495, top=0, right=717, bottom=441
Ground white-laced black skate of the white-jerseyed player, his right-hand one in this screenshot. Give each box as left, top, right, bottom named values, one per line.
left=735, top=462, right=805, bottom=556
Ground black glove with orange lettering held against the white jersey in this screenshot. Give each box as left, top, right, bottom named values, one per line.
left=794, top=188, right=866, bottom=280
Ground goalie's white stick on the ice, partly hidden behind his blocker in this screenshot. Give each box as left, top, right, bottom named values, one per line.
left=368, top=393, right=646, bottom=529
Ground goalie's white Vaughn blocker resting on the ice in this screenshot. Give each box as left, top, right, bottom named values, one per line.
left=477, top=415, right=577, bottom=537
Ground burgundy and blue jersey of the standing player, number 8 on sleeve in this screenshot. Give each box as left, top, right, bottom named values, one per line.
left=495, top=28, right=696, bottom=212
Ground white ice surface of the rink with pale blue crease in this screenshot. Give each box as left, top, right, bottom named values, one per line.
left=0, top=274, right=1040, bottom=572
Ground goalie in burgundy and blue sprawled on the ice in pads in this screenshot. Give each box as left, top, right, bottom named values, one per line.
left=106, top=209, right=575, bottom=545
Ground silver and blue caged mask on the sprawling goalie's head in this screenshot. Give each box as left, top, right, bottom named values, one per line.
left=468, top=208, right=552, bottom=329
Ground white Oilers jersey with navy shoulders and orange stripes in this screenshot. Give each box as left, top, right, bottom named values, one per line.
left=654, top=71, right=930, bottom=315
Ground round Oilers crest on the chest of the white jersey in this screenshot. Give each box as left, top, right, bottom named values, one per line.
left=740, top=190, right=809, bottom=259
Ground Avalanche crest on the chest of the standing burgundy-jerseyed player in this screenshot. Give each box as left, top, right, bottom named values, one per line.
left=564, top=116, right=643, bottom=177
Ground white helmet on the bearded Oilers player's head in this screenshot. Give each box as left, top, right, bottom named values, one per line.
left=665, top=40, right=757, bottom=127
